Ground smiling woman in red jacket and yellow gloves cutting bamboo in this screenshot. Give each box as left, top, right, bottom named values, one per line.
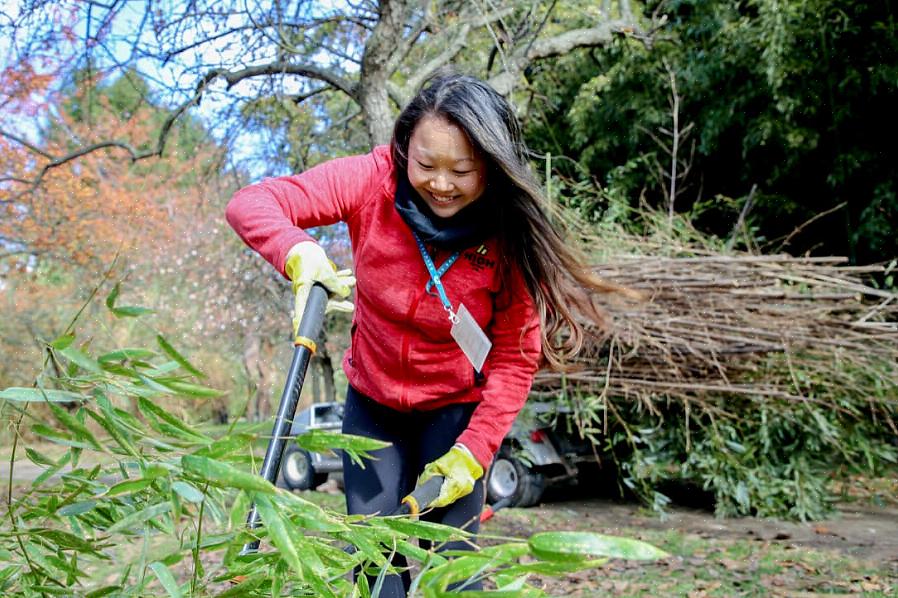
left=227, top=74, right=610, bottom=596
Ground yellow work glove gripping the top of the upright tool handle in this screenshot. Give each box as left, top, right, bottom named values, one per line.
left=284, top=241, right=355, bottom=335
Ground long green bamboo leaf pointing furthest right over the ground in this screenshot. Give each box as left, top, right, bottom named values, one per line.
left=527, top=531, right=670, bottom=561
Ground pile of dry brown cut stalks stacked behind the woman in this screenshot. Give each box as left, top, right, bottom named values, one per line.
left=534, top=252, right=898, bottom=434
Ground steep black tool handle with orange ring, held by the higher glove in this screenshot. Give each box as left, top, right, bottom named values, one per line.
left=240, top=282, right=328, bottom=554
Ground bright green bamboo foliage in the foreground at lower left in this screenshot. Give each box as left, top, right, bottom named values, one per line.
left=0, top=285, right=664, bottom=596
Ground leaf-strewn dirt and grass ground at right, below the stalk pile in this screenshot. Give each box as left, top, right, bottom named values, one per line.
left=482, top=493, right=898, bottom=598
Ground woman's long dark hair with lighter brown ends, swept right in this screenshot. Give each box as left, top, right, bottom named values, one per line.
left=391, top=72, right=618, bottom=369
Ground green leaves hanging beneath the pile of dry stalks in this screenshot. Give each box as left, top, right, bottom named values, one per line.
left=572, top=352, right=898, bottom=521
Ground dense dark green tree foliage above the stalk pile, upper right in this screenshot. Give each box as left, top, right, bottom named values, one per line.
left=527, top=0, right=898, bottom=262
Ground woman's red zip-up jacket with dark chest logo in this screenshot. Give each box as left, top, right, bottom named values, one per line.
left=226, top=146, right=540, bottom=468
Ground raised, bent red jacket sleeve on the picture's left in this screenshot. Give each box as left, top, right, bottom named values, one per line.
left=225, top=146, right=392, bottom=275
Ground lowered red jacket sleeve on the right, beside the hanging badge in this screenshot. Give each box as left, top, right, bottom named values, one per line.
left=458, top=268, right=541, bottom=470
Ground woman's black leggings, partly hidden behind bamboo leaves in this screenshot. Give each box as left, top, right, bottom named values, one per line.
left=343, top=386, right=484, bottom=598
